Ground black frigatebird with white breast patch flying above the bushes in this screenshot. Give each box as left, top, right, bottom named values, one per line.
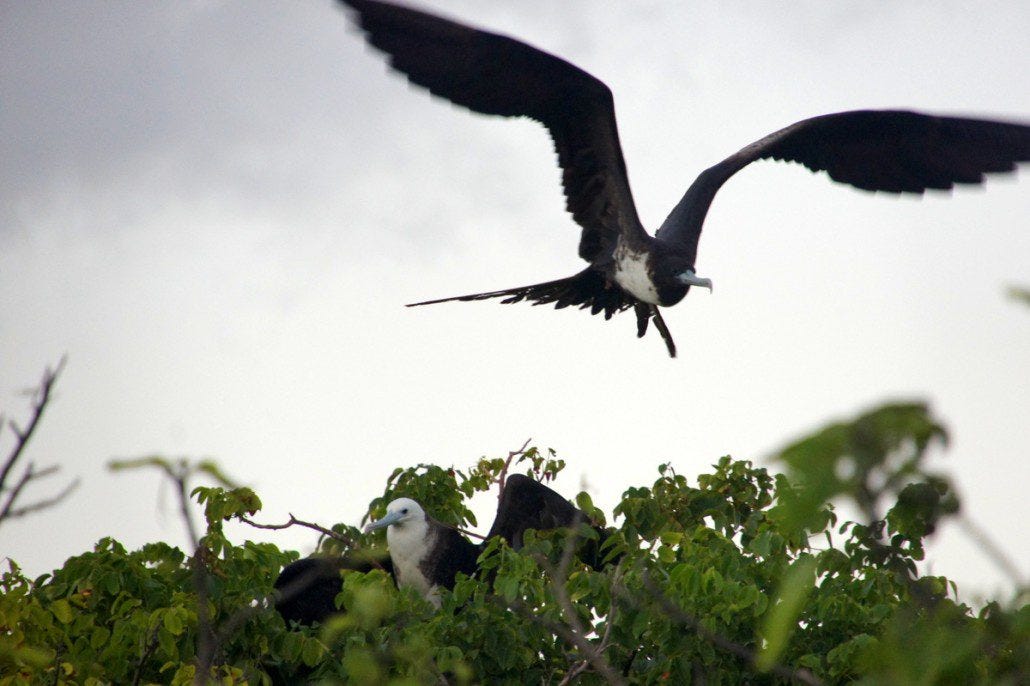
left=341, top=0, right=1030, bottom=357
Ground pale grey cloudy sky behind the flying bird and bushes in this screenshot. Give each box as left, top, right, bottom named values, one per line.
left=0, top=0, right=1030, bottom=594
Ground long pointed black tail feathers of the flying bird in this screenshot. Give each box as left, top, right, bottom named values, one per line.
left=408, top=267, right=643, bottom=321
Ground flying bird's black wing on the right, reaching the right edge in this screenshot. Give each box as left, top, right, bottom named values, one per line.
left=656, top=110, right=1030, bottom=262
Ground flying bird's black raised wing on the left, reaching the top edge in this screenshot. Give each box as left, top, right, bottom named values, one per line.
left=341, top=0, right=646, bottom=262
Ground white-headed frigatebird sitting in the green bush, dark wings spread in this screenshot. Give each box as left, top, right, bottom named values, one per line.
left=275, top=474, right=607, bottom=624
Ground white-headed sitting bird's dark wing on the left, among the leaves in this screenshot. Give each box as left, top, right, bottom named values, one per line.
left=274, top=553, right=393, bottom=625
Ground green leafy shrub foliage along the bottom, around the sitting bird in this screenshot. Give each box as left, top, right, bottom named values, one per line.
left=0, top=405, right=1030, bottom=684
